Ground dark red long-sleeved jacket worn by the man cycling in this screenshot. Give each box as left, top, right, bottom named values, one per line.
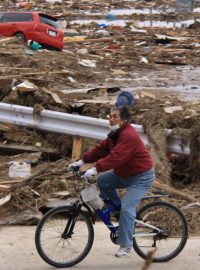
left=82, top=124, right=153, bottom=177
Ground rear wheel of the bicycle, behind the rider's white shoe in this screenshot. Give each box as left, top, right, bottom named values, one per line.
left=133, top=201, right=188, bottom=262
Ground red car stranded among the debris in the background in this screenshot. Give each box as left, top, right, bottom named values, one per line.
left=0, top=11, right=64, bottom=50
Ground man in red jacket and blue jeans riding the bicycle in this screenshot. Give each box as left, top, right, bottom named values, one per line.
left=69, top=104, right=155, bottom=257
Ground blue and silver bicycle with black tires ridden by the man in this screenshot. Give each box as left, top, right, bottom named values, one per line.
left=35, top=171, right=188, bottom=268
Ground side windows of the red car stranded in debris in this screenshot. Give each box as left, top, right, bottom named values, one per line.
left=0, top=13, right=33, bottom=22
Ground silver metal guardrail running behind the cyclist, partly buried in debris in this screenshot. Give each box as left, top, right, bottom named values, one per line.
left=0, top=103, right=190, bottom=155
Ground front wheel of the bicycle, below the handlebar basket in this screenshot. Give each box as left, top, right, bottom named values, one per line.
left=35, top=206, right=94, bottom=268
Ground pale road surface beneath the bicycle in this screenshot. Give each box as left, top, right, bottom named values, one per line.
left=0, top=223, right=200, bottom=270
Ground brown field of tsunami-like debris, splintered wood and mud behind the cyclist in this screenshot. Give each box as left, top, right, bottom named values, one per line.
left=0, top=1, right=200, bottom=234
